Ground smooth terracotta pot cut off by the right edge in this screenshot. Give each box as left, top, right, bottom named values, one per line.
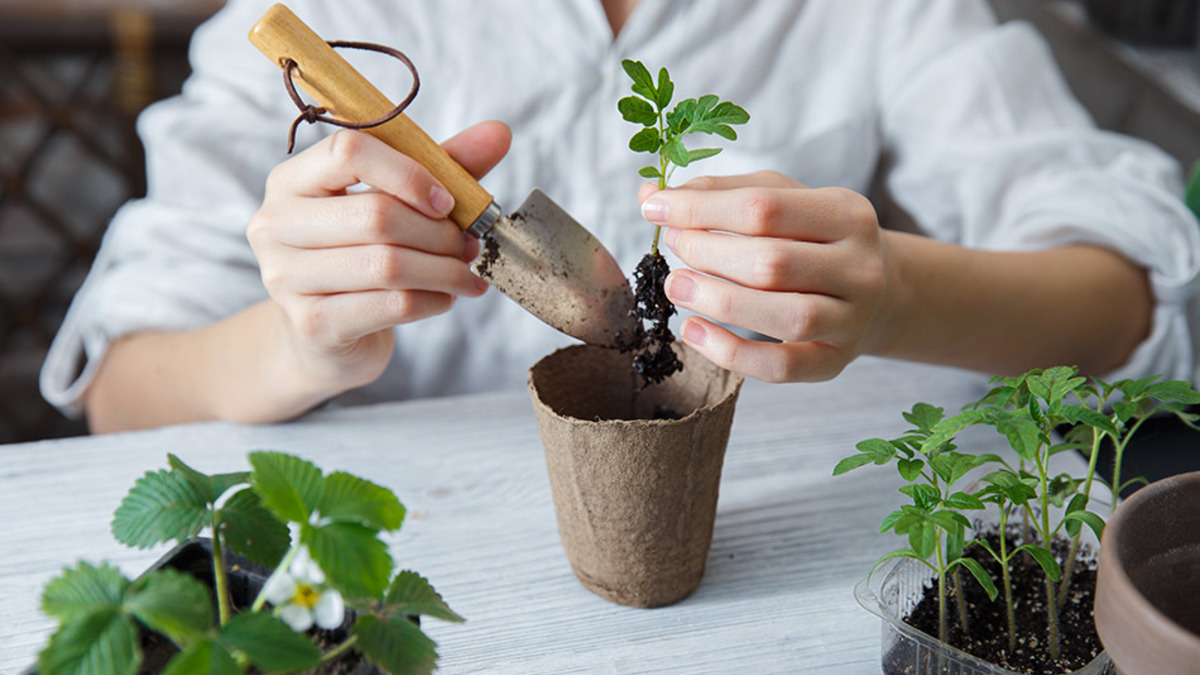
left=1096, top=472, right=1200, bottom=675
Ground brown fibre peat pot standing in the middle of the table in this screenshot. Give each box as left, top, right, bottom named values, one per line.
left=529, top=345, right=742, bottom=607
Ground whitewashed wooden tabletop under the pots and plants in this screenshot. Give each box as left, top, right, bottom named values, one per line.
left=0, top=359, right=1032, bottom=674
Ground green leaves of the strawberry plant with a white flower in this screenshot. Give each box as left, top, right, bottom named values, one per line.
left=38, top=452, right=463, bottom=675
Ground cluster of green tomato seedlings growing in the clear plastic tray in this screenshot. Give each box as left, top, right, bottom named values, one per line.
left=834, top=365, right=1200, bottom=653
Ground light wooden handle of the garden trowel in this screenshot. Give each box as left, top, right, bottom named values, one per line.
left=250, top=5, right=492, bottom=229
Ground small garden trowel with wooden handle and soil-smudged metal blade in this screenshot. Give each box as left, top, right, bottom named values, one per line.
left=250, top=5, right=636, bottom=347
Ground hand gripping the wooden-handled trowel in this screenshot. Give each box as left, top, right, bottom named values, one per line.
left=246, top=121, right=511, bottom=396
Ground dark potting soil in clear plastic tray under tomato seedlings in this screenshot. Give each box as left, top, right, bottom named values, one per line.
left=883, top=531, right=1103, bottom=675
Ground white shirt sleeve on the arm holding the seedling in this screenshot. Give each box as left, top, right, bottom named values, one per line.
left=880, top=2, right=1200, bottom=380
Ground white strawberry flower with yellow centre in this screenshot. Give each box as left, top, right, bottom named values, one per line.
left=263, top=546, right=346, bottom=633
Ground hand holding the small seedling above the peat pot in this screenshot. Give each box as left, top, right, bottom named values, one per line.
left=638, top=172, right=887, bottom=382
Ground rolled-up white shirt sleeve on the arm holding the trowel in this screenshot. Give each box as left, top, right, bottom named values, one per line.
left=41, top=1, right=296, bottom=414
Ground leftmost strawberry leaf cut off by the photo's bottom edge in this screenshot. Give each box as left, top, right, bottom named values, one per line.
left=37, top=609, right=142, bottom=675
